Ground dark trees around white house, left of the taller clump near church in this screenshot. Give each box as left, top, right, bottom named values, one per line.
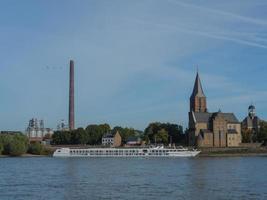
left=52, top=124, right=140, bottom=145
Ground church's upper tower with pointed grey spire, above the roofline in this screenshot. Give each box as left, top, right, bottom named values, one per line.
left=190, top=72, right=207, bottom=112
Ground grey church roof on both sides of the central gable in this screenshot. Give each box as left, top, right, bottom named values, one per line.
left=194, top=112, right=239, bottom=124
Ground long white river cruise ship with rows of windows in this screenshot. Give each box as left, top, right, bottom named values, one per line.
left=53, top=147, right=200, bottom=157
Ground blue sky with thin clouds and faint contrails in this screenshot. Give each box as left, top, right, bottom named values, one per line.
left=0, top=0, right=267, bottom=131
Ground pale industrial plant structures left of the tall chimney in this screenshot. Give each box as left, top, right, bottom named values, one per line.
left=26, top=118, right=54, bottom=141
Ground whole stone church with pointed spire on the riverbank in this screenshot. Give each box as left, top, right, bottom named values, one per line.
left=188, top=73, right=241, bottom=147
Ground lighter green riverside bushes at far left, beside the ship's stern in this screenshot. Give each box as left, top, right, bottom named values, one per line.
left=0, top=133, right=51, bottom=156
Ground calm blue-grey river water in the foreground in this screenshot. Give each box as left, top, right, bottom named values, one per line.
left=0, top=157, right=267, bottom=200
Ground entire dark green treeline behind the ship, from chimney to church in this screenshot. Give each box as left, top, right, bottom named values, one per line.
left=52, top=122, right=186, bottom=145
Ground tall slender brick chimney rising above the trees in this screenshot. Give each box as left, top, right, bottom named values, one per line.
left=69, top=60, right=75, bottom=130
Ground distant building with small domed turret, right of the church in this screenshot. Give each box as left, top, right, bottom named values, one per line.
left=242, top=105, right=261, bottom=142
